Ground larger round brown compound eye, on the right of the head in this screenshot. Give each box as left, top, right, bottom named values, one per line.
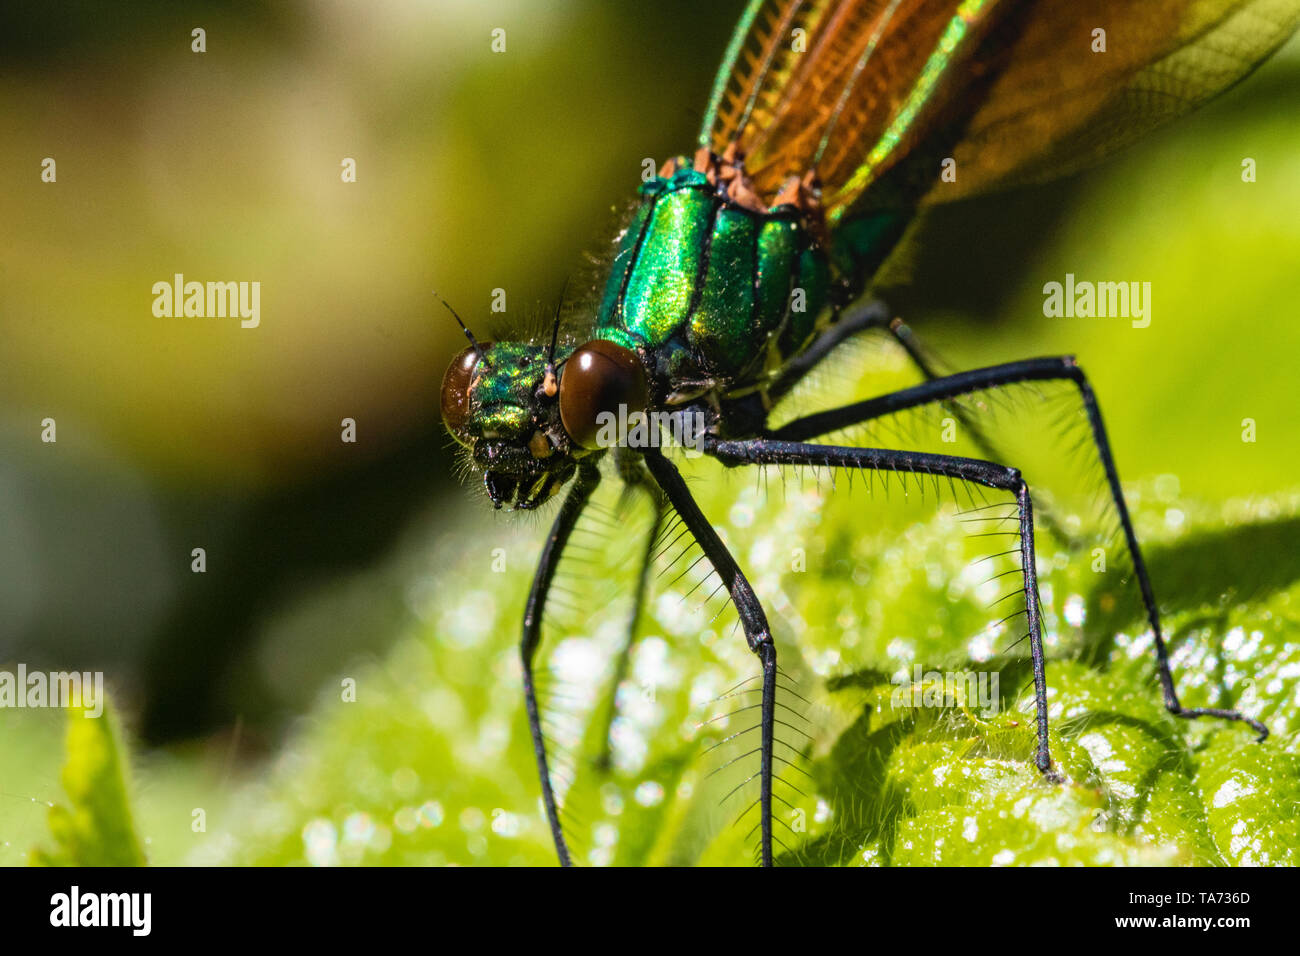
left=560, top=338, right=649, bottom=449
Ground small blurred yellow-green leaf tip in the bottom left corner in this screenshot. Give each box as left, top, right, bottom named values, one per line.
left=31, top=701, right=144, bottom=866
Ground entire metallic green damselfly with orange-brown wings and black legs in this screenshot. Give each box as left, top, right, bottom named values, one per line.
left=442, top=0, right=1300, bottom=865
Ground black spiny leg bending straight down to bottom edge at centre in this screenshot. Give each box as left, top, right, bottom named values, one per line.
left=634, top=449, right=776, bottom=866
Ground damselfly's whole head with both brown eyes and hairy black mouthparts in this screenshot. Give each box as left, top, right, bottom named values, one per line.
left=442, top=339, right=647, bottom=511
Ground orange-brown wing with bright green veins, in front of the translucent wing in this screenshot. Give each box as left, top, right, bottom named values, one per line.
left=701, top=0, right=1015, bottom=218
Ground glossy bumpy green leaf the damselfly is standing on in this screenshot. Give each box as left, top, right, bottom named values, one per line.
left=195, top=483, right=1300, bottom=866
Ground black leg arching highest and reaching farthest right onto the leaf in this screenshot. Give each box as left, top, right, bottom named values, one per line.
left=767, top=356, right=1269, bottom=740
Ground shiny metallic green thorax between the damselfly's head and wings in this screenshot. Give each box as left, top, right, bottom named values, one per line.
left=595, top=161, right=831, bottom=393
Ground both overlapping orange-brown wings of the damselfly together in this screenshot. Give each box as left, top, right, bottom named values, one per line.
left=701, top=0, right=1300, bottom=221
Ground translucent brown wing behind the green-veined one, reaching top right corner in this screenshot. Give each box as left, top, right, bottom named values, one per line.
left=926, top=0, right=1300, bottom=203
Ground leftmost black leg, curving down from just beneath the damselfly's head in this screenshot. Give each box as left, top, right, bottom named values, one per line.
left=519, top=466, right=601, bottom=866
